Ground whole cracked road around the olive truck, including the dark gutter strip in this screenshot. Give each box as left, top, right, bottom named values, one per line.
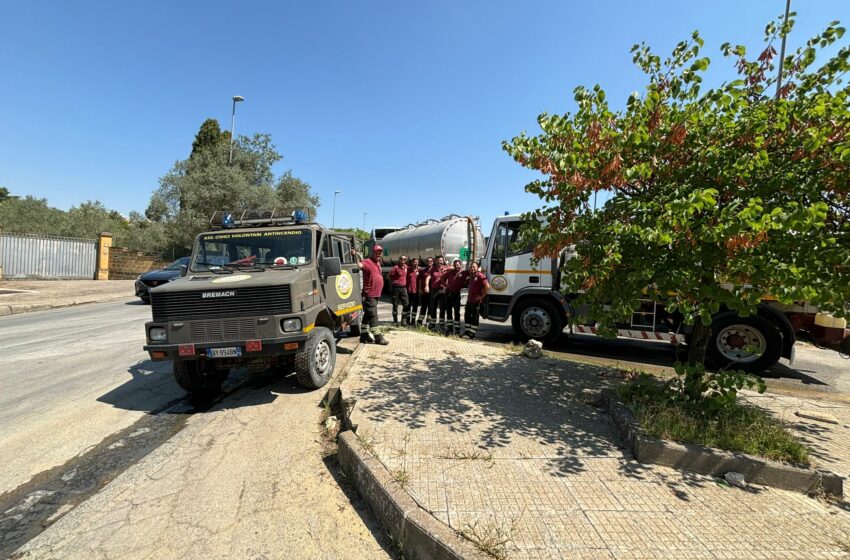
left=0, top=302, right=389, bottom=559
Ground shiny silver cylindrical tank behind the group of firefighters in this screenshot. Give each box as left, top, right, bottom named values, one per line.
left=381, top=215, right=485, bottom=268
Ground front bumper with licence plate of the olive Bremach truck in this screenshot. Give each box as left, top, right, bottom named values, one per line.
left=144, top=333, right=307, bottom=362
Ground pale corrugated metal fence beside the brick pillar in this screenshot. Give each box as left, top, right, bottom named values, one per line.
left=0, top=233, right=97, bottom=279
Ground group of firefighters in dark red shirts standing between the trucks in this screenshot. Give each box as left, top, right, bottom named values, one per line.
left=352, top=245, right=490, bottom=344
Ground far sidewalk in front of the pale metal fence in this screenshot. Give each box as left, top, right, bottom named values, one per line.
left=0, top=280, right=135, bottom=316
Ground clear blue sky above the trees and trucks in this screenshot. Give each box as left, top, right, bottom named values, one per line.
left=0, top=0, right=850, bottom=235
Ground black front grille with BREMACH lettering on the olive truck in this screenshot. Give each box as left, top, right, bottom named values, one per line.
left=151, top=285, right=292, bottom=321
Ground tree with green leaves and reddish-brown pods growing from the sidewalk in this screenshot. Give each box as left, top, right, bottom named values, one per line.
left=503, top=14, right=850, bottom=404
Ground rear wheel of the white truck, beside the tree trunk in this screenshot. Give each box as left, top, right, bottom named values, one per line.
left=705, top=311, right=782, bottom=373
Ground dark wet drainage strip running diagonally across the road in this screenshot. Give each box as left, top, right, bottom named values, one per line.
left=0, top=372, right=247, bottom=558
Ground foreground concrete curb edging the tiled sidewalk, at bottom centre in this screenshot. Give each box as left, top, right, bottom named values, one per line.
left=337, top=431, right=490, bottom=560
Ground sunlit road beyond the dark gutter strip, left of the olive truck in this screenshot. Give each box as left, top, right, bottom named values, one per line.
left=0, top=301, right=176, bottom=495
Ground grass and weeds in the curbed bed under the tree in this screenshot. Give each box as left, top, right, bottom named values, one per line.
left=619, top=382, right=809, bottom=466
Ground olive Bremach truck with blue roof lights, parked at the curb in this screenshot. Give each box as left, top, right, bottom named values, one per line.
left=145, top=210, right=363, bottom=394
